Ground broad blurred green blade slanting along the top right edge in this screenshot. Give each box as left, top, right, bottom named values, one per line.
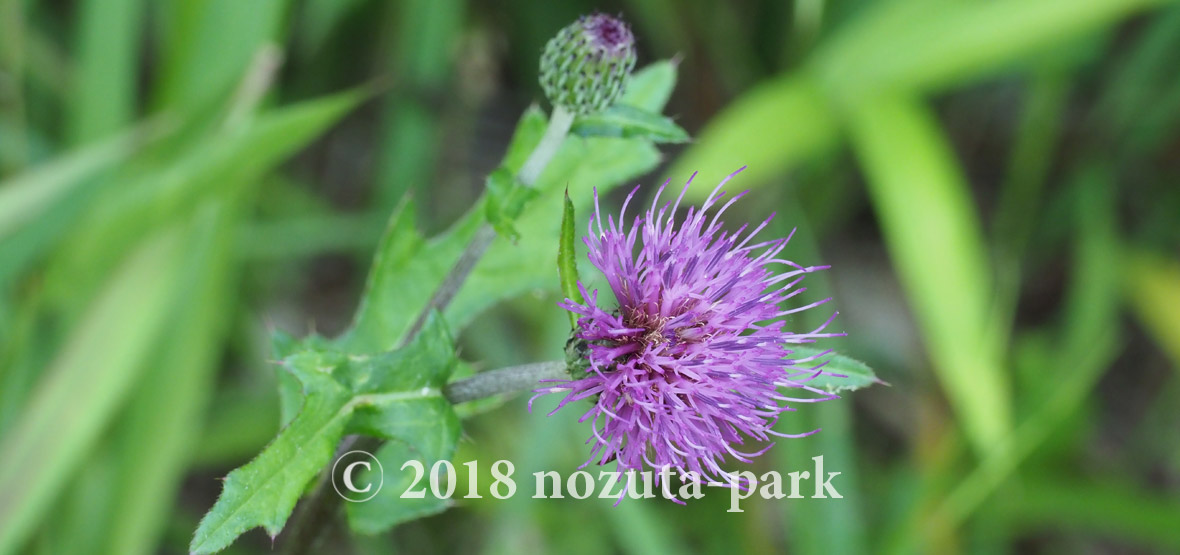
left=813, top=0, right=1166, bottom=99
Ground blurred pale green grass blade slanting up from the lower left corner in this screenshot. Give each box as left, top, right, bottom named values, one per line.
left=0, top=233, right=181, bottom=554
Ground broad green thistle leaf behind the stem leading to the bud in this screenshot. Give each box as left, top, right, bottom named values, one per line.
left=341, top=60, right=675, bottom=352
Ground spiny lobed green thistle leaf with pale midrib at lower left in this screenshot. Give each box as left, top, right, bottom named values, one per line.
left=190, top=314, right=459, bottom=553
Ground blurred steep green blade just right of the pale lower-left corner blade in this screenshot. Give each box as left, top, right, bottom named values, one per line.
left=104, top=205, right=240, bottom=555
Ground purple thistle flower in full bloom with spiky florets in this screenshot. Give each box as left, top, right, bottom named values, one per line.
left=530, top=168, right=844, bottom=491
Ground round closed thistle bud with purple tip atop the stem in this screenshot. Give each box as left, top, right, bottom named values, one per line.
left=540, top=13, right=635, bottom=115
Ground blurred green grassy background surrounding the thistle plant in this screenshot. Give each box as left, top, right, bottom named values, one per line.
left=0, top=0, right=1180, bottom=554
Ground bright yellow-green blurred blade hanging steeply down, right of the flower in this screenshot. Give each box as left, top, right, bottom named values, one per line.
left=851, top=98, right=1011, bottom=452
